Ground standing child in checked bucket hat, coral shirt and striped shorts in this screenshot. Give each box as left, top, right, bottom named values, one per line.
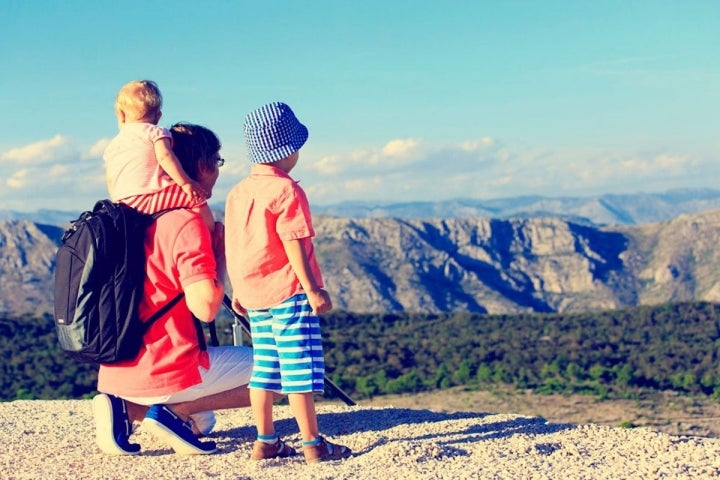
left=225, top=102, right=352, bottom=463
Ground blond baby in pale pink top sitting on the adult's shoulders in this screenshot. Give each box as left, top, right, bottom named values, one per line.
left=103, top=80, right=215, bottom=231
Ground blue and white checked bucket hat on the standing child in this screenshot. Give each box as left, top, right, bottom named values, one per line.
left=243, top=102, right=308, bottom=163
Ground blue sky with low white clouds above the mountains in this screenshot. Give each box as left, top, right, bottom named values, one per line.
left=0, top=0, right=720, bottom=210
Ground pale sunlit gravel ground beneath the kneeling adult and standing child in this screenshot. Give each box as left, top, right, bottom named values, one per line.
left=0, top=400, right=720, bottom=480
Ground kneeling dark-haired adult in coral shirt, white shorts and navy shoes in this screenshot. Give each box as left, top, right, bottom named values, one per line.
left=93, top=124, right=252, bottom=455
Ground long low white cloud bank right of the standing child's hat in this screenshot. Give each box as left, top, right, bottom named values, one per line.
left=303, top=137, right=713, bottom=204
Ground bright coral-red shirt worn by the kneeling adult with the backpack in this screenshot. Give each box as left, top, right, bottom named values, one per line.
left=98, top=210, right=216, bottom=397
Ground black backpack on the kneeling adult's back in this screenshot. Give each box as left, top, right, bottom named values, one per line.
left=55, top=200, right=183, bottom=363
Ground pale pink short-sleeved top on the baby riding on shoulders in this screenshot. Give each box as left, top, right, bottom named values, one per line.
left=103, top=123, right=175, bottom=202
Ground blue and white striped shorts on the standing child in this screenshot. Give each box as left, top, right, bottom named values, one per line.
left=248, top=293, right=325, bottom=394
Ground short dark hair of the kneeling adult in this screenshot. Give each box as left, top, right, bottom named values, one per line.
left=170, top=122, right=222, bottom=180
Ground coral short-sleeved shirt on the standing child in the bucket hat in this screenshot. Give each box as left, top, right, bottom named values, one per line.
left=225, top=164, right=323, bottom=309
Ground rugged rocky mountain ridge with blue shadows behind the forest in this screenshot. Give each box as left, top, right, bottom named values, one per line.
left=0, top=189, right=720, bottom=313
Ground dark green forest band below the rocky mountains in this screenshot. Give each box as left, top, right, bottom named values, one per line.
left=0, top=302, right=720, bottom=401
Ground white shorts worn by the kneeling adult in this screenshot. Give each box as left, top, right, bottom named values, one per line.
left=123, top=345, right=253, bottom=405
